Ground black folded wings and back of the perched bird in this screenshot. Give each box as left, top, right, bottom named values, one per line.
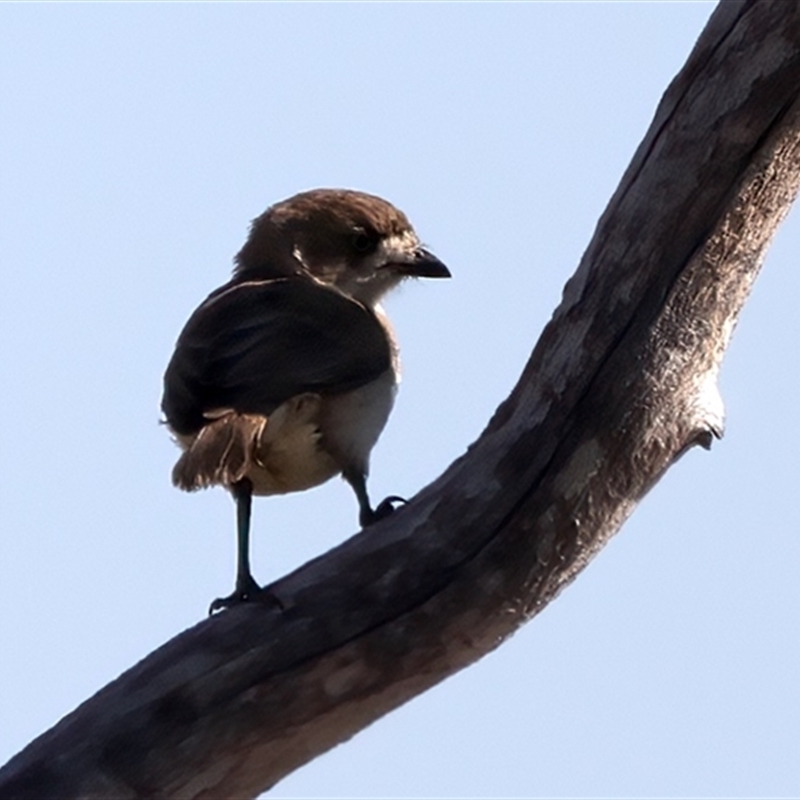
left=161, top=278, right=392, bottom=434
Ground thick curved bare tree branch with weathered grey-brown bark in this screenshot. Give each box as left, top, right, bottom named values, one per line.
left=0, top=0, right=800, bottom=800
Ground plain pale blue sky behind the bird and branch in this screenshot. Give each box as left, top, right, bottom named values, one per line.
left=0, top=2, right=800, bottom=798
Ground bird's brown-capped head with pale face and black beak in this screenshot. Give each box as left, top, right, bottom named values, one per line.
left=234, top=189, right=450, bottom=305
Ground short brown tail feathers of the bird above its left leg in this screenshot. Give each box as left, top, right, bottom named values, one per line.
left=172, top=411, right=267, bottom=492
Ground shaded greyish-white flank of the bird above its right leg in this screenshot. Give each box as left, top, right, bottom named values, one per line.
left=320, top=369, right=397, bottom=474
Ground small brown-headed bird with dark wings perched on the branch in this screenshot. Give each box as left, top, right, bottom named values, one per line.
left=161, top=189, right=451, bottom=614
